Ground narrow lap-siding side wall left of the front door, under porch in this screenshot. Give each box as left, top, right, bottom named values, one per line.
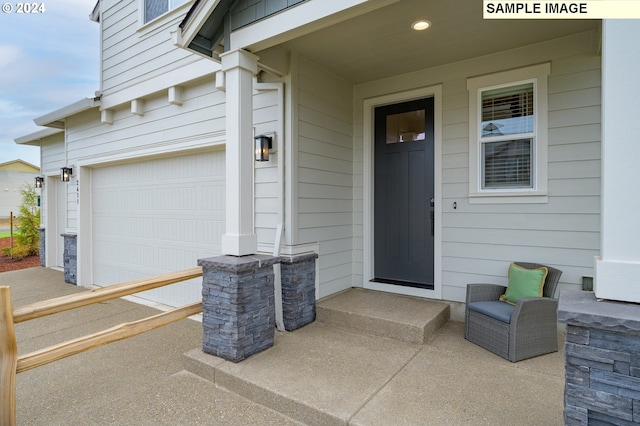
left=297, top=59, right=353, bottom=297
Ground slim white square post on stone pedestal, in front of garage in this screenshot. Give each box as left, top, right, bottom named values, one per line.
left=220, top=50, right=258, bottom=256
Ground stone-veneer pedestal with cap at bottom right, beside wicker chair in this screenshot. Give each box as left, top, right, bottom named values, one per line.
left=558, top=290, right=640, bottom=425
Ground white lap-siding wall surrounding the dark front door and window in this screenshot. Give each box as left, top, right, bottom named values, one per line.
left=354, top=33, right=600, bottom=301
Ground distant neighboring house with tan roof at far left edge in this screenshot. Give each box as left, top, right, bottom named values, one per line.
left=0, top=160, right=40, bottom=219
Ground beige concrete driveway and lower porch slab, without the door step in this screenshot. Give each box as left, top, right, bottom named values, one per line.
left=0, top=267, right=564, bottom=425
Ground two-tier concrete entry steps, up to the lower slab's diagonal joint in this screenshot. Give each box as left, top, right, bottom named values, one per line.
left=185, top=289, right=449, bottom=426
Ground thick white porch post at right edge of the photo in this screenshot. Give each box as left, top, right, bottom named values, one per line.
left=594, top=19, right=640, bottom=303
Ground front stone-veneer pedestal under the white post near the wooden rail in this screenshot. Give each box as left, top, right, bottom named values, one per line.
left=198, top=254, right=280, bottom=362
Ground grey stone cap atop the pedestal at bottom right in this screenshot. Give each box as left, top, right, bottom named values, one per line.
left=558, top=290, right=640, bottom=334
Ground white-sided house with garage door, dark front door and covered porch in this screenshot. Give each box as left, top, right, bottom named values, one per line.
left=13, top=0, right=640, bottom=312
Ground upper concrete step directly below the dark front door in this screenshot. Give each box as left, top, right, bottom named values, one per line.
left=316, top=288, right=450, bottom=344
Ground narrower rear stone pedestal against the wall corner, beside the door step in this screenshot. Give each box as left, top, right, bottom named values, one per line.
left=280, top=253, right=318, bottom=331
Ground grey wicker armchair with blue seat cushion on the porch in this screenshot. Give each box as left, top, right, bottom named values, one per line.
left=464, top=262, right=562, bottom=362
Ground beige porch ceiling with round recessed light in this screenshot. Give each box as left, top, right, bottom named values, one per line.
left=276, top=0, right=600, bottom=84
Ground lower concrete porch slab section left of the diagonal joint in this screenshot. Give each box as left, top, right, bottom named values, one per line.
left=184, top=321, right=425, bottom=426
